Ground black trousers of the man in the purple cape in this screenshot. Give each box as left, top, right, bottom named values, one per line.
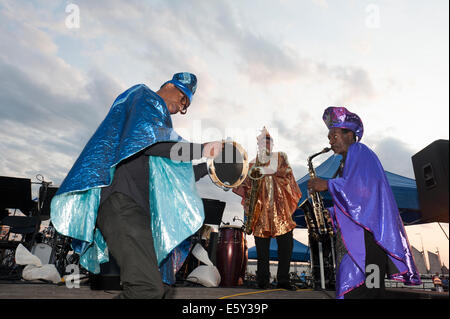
left=344, top=230, right=388, bottom=299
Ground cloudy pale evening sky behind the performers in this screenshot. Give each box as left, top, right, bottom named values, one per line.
left=0, top=0, right=449, bottom=266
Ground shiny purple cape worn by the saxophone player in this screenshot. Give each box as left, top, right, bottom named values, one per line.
left=328, top=143, right=421, bottom=298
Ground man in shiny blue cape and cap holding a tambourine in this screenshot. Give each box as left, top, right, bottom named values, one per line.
left=51, top=73, right=221, bottom=298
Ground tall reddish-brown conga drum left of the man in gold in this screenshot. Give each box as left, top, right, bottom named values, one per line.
left=216, top=226, right=247, bottom=287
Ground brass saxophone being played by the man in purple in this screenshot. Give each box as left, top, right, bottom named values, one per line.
left=305, top=147, right=333, bottom=236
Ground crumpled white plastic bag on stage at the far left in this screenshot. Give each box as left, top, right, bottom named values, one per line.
left=15, top=244, right=61, bottom=284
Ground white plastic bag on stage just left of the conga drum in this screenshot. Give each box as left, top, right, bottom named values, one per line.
left=186, top=244, right=220, bottom=287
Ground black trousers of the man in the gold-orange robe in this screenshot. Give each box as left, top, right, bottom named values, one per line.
left=255, top=231, right=294, bottom=285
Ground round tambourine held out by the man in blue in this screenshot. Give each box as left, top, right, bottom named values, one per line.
left=206, top=140, right=248, bottom=191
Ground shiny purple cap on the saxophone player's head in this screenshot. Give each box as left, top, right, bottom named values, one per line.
left=322, top=106, right=364, bottom=141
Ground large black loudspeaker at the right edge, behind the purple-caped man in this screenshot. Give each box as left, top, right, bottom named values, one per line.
left=411, top=140, right=449, bottom=223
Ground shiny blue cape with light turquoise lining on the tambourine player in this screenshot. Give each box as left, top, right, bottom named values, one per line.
left=51, top=84, right=204, bottom=280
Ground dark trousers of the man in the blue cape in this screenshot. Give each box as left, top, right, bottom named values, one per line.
left=97, top=192, right=165, bottom=299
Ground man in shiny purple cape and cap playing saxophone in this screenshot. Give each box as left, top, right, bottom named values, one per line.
left=308, top=107, right=421, bottom=299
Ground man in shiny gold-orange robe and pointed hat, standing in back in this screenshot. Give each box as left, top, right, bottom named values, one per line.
left=233, top=128, right=302, bottom=290
